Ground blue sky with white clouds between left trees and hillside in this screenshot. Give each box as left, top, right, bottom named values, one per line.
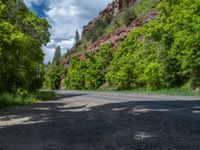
left=24, top=0, right=113, bottom=62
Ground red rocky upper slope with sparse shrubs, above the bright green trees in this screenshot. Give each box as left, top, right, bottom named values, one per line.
left=63, top=0, right=159, bottom=67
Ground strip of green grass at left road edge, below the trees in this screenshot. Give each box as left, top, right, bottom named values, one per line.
left=0, top=91, right=55, bottom=109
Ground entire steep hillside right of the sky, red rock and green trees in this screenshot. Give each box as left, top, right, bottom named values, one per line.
left=45, top=0, right=200, bottom=91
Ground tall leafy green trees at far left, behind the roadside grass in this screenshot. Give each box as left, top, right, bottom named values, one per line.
left=0, top=0, right=50, bottom=92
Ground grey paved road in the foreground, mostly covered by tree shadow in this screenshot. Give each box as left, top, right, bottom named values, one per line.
left=0, top=91, right=200, bottom=150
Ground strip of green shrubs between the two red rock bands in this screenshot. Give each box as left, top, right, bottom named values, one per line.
left=86, top=0, right=161, bottom=42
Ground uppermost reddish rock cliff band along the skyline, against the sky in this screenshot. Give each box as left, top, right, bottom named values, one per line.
left=82, top=0, right=137, bottom=38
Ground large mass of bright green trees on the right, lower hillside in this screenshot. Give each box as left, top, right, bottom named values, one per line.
left=106, top=0, right=200, bottom=90
